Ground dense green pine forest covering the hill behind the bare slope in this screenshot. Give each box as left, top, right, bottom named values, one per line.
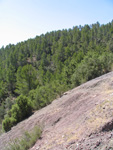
left=0, top=21, right=113, bottom=131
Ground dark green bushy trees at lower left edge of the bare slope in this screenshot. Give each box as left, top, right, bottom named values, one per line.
left=2, top=95, right=32, bottom=132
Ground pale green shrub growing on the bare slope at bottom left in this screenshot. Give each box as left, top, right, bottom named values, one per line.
left=6, top=126, right=42, bottom=150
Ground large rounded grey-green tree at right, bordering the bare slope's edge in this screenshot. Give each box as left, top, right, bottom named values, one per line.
left=71, top=52, right=113, bottom=86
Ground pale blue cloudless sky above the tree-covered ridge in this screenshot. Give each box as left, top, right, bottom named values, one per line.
left=0, top=0, right=113, bottom=48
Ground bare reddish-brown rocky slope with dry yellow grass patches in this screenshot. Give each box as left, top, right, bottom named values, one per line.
left=0, top=72, right=113, bottom=150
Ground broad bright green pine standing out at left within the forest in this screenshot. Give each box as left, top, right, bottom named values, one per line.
left=15, top=64, right=38, bottom=95
